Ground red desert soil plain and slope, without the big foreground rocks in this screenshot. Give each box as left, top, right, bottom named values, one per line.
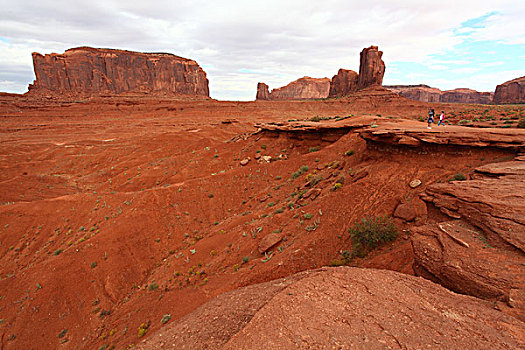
left=0, top=89, right=525, bottom=349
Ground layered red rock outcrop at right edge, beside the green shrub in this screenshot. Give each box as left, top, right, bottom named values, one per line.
left=412, top=157, right=525, bottom=320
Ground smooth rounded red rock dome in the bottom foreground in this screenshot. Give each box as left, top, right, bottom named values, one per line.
left=137, top=267, right=525, bottom=349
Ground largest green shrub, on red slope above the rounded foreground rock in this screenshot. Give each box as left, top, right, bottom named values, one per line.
left=343, top=215, right=398, bottom=260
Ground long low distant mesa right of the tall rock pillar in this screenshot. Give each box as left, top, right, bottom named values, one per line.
left=383, top=84, right=493, bottom=104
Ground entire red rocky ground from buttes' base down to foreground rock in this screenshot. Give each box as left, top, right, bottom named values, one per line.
left=0, top=89, right=525, bottom=349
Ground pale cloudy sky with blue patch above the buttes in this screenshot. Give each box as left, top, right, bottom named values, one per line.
left=0, top=0, right=525, bottom=100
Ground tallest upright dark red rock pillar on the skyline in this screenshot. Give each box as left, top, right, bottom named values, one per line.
left=357, top=46, right=385, bottom=89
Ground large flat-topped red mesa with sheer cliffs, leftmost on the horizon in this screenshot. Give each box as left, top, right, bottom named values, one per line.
left=29, top=47, right=209, bottom=97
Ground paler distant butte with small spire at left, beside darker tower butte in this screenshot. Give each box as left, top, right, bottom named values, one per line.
left=257, top=77, right=330, bottom=100
